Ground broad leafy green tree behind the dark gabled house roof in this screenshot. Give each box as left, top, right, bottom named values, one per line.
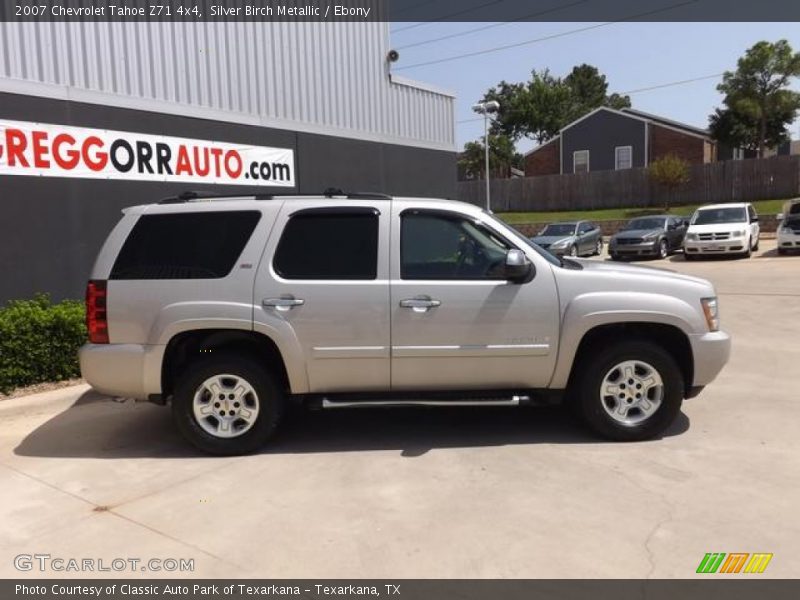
left=482, top=64, right=631, bottom=144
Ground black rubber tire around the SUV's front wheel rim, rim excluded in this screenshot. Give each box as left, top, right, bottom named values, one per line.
left=571, top=340, right=684, bottom=442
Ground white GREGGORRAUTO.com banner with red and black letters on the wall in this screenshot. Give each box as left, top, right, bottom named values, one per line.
left=0, top=119, right=295, bottom=187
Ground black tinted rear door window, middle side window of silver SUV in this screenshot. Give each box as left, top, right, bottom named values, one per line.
left=273, top=209, right=378, bottom=279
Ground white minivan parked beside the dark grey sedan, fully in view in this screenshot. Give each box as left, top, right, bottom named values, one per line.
left=683, top=202, right=761, bottom=260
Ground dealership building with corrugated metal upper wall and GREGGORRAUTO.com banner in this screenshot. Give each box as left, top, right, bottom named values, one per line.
left=0, top=22, right=456, bottom=303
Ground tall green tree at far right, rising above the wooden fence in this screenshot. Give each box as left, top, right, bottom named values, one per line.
left=709, top=40, right=800, bottom=158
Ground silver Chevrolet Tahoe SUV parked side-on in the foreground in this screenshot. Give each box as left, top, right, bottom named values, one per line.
left=80, top=191, right=730, bottom=454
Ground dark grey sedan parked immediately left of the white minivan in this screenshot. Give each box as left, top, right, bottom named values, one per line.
left=608, top=215, right=686, bottom=260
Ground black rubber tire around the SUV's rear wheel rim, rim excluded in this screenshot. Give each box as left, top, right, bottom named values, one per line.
left=172, top=354, right=284, bottom=456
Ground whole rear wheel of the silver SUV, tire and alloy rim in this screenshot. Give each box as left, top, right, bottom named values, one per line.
left=172, top=355, right=283, bottom=455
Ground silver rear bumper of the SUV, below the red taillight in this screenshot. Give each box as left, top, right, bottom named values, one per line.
left=78, top=344, right=164, bottom=400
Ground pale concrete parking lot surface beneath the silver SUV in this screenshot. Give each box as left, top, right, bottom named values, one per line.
left=0, top=241, right=800, bottom=578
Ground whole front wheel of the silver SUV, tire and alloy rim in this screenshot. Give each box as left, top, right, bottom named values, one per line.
left=573, top=340, right=684, bottom=441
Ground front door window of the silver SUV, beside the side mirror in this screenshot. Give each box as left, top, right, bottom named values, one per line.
left=400, top=212, right=510, bottom=280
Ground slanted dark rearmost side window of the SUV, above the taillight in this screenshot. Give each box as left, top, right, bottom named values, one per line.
left=111, top=211, right=261, bottom=279
